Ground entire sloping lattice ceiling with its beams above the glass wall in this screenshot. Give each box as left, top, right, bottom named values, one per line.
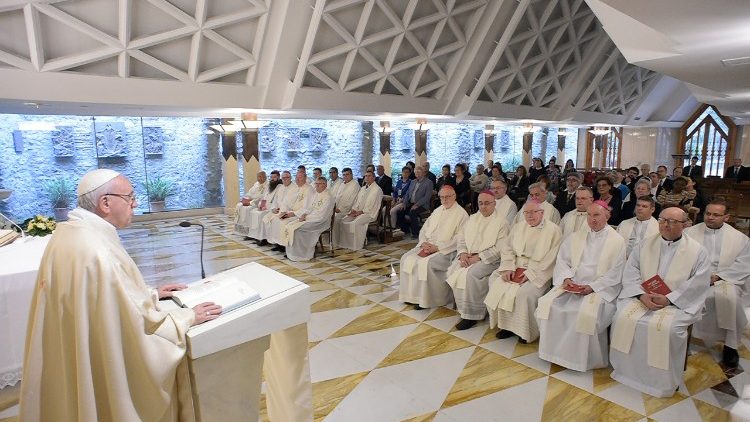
left=0, top=0, right=712, bottom=126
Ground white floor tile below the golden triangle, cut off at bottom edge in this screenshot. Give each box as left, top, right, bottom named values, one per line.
left=435, top=377, right=547, bottom=422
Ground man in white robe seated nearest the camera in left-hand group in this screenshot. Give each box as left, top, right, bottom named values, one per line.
left=279, top=177, right=333, bottom=261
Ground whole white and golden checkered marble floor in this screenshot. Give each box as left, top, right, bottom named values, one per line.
left=117, top=216, right=750, bottom=422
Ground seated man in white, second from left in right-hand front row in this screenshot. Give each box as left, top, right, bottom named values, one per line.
left=448, top=190, right=516, bottom=330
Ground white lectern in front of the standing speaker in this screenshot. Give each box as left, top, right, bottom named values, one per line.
left=187, top=262, right=310, bottom=422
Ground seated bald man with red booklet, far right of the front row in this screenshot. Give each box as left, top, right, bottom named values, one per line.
left=609, top=207, right=710, bottom=397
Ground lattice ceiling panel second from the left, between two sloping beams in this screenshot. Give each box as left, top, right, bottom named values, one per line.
left=301, top=0, right=487, bottom=99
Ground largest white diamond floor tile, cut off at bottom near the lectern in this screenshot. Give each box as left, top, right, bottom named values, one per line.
left=326, top=347, right=474, bottom=422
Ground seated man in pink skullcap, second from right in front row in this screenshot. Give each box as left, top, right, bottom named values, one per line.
left=536, top=203, right=625, bottom=372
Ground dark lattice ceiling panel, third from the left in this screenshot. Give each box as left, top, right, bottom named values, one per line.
left=479, top=0, right=606, bottom=107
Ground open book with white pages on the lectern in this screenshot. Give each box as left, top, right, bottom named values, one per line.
left=172, top=275, right=260, bottom=313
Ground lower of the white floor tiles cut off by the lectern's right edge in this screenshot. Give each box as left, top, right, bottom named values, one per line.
left=310, top=324, right=418, bottom=383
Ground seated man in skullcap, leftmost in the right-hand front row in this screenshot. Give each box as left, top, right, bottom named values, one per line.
left=399, top=185, right=469, bottom=309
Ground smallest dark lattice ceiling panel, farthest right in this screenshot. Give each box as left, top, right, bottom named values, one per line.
left=582, top=52, right=658, bottom=115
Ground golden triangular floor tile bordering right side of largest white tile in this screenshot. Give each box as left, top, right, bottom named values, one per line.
left=442, top=347, right=546, bottom=409
